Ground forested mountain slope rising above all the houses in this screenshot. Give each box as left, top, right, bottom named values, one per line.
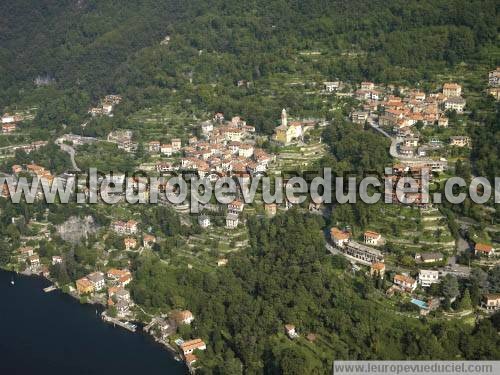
left=0, top=0, right=498, bottom=130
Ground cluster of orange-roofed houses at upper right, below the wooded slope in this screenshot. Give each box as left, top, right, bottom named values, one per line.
left=351, top=82, right=466, bottom=135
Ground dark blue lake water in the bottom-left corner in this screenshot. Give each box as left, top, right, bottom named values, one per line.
left=0, top=270, right=186, bottom=375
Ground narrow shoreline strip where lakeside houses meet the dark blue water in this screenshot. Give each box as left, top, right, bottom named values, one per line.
left=0, top=266, right=189, bottom=371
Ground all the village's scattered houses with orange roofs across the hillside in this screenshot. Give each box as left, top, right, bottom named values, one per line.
left=2, top=68, right=500, bottom=369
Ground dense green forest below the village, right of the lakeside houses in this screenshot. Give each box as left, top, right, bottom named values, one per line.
left=132, top=211, right=500, bottom=374
